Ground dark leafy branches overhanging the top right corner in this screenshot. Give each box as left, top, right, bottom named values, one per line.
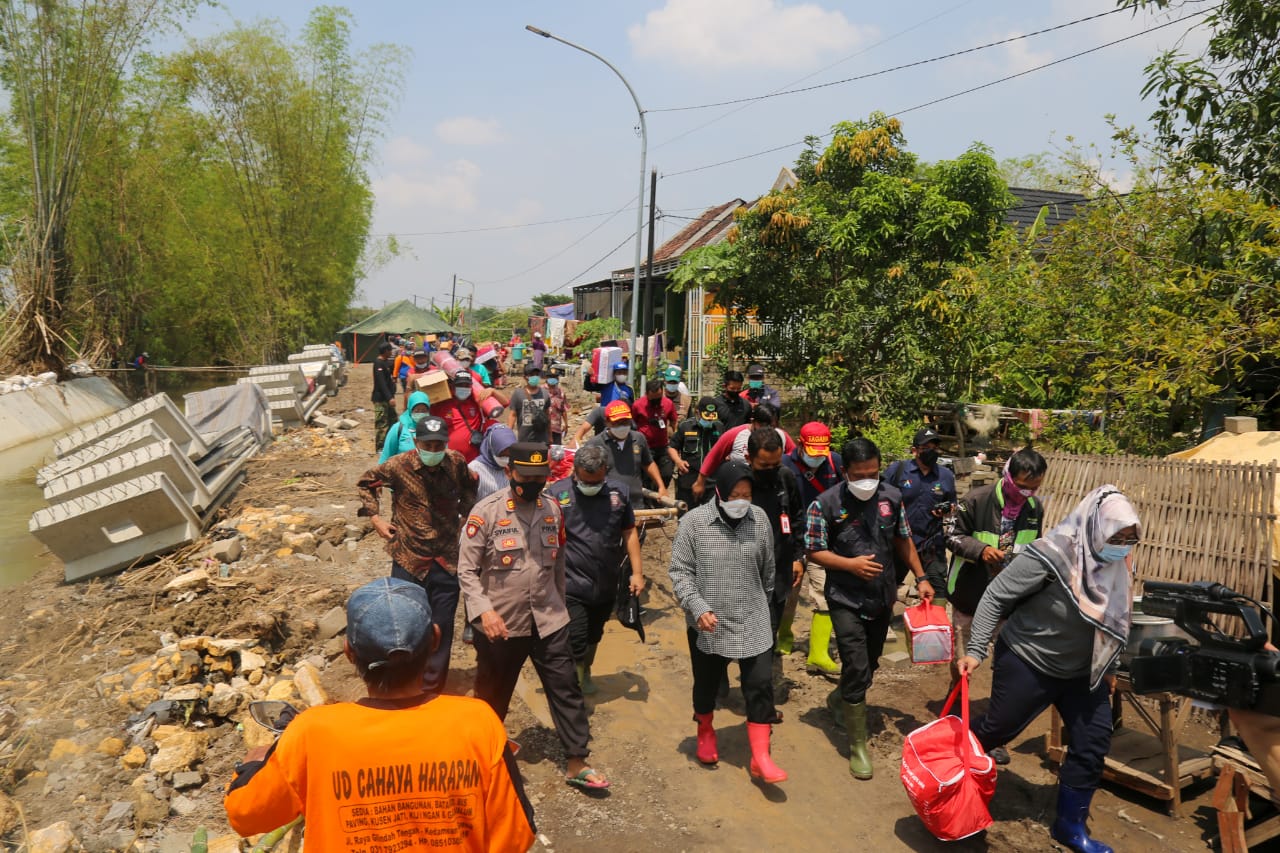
left=1119, top=0, right=1280, bottom=204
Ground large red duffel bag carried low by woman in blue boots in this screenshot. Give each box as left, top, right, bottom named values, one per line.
left=901, top=675, right=996, bottom=841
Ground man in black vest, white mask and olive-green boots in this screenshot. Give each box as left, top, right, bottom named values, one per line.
left=805, top=438, right=933, bottom=779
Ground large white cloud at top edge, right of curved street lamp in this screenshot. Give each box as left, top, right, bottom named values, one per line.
left=627, top=0, right=874, bottom=70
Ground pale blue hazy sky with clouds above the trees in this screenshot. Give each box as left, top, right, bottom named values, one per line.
left=187, top=0, right=1208, bottom=307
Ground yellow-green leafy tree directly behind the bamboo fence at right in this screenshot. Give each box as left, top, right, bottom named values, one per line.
left=962, top=146, right=1280, bottom=453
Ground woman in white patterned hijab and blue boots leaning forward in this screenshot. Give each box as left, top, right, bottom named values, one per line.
left=959, top=485, right=1142, bottom=853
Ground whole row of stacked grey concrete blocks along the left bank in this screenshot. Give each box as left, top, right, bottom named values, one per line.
left=28, top=345, right=346, bottom=580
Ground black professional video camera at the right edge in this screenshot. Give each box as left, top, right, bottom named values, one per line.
left=1129, top=580, right=1280, bottom=716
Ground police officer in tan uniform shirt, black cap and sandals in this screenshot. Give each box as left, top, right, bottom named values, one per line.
left=458, top=442, right=609, bottom=789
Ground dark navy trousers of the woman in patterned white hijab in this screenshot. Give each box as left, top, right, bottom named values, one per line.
left=970, top=639, right=1111, bottom=790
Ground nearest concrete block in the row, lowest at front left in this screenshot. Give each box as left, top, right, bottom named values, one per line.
left=28, top=474, right=201, bottom=581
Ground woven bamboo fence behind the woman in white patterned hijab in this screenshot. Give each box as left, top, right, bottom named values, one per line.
left=1041, top=453, right=1276, bottom=605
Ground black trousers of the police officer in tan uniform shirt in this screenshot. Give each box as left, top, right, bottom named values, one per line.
left=475, top=625, right=591, bottom=758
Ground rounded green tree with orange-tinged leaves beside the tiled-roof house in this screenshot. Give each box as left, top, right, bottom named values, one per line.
left=673, top=114, right=1010, bottom=421
